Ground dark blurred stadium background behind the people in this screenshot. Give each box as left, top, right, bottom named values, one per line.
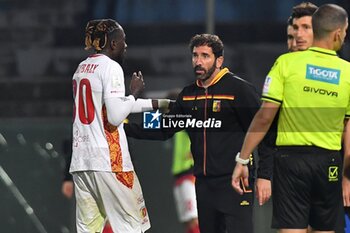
left=0, top=0, right=350, bottom=233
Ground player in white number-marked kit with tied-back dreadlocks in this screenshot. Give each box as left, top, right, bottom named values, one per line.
left=70, top=19, right=168, bottom=233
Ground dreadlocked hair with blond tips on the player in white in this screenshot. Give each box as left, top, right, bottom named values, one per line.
left=85, top=19, right=120, bottom=51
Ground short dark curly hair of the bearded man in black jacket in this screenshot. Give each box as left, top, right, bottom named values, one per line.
left=189, top=34, right=224, bottom=58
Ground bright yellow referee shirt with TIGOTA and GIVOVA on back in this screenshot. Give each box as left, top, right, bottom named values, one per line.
left=262, top=47, right=350, bottom=150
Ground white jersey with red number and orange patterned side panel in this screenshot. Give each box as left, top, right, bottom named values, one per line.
left=70, top=54, right=134, bottom=172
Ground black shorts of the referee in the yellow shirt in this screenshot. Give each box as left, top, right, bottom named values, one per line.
left=272, top=146, right=343, bottom=231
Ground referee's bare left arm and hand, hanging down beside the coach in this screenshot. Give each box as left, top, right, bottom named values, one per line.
left=232, top=101, right=280, bottom=194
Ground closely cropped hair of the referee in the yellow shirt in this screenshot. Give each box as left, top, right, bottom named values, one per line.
left=312, top=4, right=348, bottom=39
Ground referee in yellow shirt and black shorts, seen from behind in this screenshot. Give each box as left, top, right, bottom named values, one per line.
left=232, top=4, right=350, bottom=233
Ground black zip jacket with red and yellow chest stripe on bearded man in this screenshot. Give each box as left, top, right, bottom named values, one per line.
left=125, top=68, right=272, bottom=179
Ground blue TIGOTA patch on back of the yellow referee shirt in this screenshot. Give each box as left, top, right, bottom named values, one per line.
left=306, top=65, right=340, bottom=85
